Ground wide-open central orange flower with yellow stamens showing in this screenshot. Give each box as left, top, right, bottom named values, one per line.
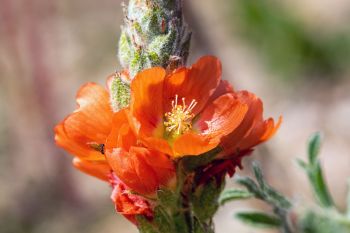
left=129, top=56, right=248, bottom=158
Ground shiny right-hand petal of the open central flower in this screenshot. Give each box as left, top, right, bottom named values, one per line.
left=194, top=93, right=248, bottom=142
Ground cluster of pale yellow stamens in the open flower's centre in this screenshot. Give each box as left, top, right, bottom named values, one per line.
left=164, top=95, right=197, bottom=136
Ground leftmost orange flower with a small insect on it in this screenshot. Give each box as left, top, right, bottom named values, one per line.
left=55, top=83, right=113, bottom=181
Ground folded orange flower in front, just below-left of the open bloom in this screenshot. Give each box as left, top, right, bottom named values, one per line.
left=106, top=110, right=175, bottom=194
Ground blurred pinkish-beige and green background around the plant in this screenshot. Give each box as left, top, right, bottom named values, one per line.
left=0, top=0, right=350, bottom=233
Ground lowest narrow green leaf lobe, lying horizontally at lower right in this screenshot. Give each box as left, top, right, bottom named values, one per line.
left=236, top=212, right=282, bottom=228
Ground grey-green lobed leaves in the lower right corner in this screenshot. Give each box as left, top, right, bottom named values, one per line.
left=223, top=133, right=350, bottom=233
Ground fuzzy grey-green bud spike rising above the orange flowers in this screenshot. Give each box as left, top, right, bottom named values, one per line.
left=112, top=0, right=191, bottom=111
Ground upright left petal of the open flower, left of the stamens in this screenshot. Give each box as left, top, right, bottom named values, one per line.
left=130, top=67, right=165, bottom=136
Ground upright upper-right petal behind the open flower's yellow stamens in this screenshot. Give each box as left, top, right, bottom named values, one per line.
left=164, top=56, right=221, bottom=114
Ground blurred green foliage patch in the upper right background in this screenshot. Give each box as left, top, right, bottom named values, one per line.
left=231, top=0, right=350, bottom=79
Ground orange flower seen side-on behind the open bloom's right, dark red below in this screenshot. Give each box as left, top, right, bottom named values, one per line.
left=199, top=90, right=282, bottom=183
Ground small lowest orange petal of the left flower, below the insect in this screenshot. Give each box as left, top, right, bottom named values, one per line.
left=73, top=157, right=112, bottom=181
